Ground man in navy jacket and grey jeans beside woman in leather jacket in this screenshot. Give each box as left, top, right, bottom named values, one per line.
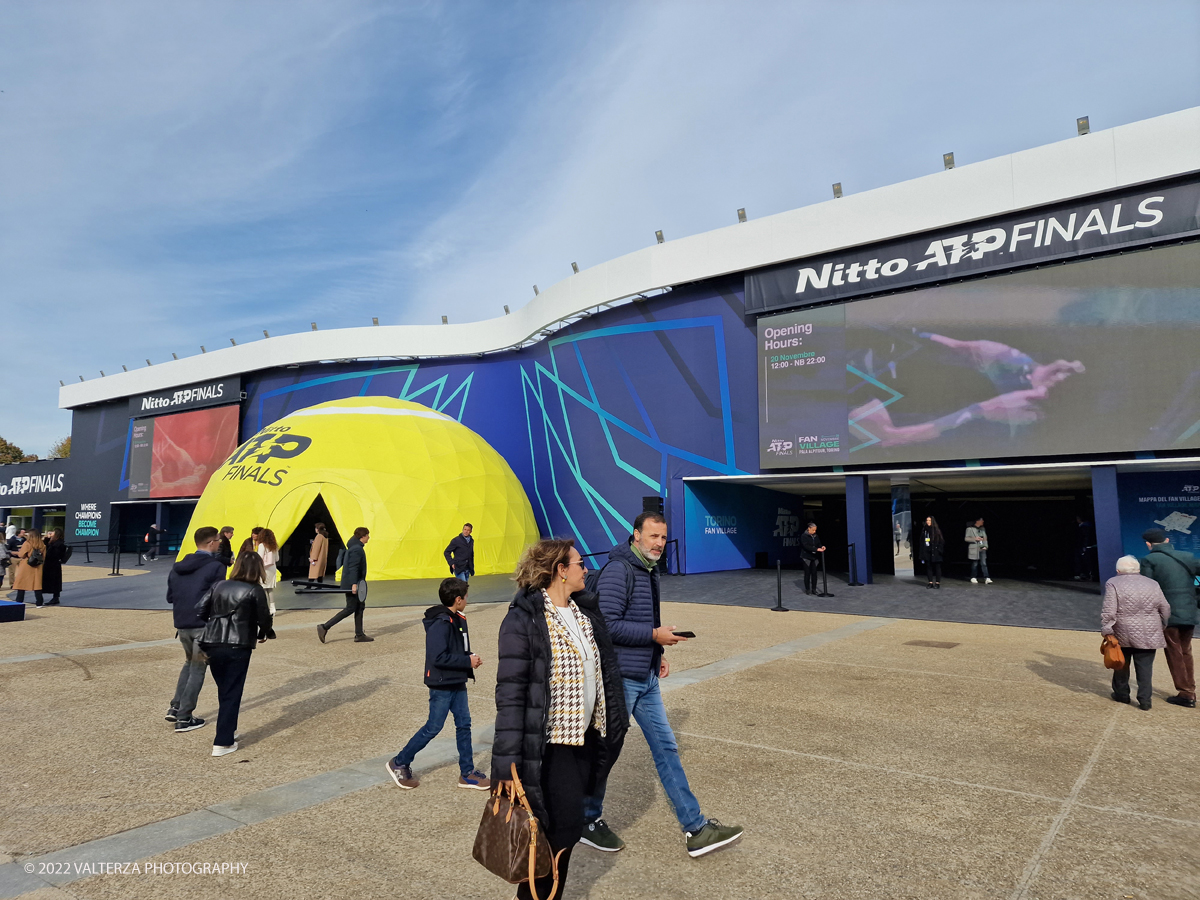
left=166, top=526, right=226, bottom=733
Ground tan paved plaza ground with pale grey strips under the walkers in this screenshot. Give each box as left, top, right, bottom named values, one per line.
left=0, top=595, right=1200, bottom=900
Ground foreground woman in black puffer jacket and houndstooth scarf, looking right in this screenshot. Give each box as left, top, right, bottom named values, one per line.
left=492, top=540, right=629, bottom=900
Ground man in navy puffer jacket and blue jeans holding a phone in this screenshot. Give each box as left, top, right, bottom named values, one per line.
left=581, top=512, right=742, bottom=857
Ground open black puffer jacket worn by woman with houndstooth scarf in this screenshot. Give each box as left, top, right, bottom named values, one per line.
left=492, top=588, right=629, bottom=822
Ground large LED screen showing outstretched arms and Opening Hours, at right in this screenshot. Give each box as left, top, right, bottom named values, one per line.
left=758, top=242, right=1200, bottom=468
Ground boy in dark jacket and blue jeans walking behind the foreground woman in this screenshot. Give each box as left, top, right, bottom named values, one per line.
left=386, top=578, right=492, bottom=791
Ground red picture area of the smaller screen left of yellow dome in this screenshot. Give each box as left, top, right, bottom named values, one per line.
left=150, top=406, right=239, bottom=497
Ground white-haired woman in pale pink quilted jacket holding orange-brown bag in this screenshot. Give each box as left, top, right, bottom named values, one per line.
left=1100, top=557, right=1171, bottom=709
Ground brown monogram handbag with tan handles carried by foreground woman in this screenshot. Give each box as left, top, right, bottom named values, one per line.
left=472, top=763, right=558, bottom=900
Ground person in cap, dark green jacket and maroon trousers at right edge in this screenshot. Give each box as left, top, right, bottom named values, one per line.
left=1141, top=528, right=1200, bottom=709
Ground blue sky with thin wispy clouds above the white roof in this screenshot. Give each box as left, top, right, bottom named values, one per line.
left=0, top=0, right=1200, bottom=454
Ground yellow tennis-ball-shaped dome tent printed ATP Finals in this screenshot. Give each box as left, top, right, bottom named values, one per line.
left=180, top=397, right=538, bottom=580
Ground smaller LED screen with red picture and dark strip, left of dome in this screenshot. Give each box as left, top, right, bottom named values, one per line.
left=130, top=404, right=239, bottom=499
